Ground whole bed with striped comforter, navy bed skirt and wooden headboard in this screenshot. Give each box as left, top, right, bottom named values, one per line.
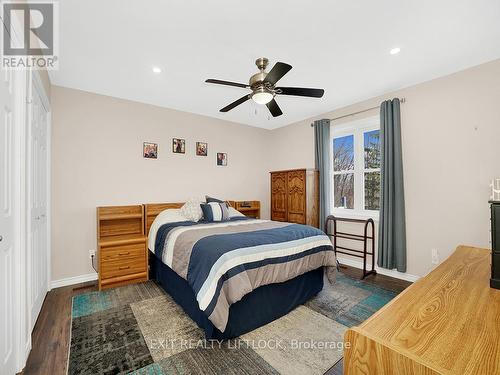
left=145, top=203, right=335, bottom=340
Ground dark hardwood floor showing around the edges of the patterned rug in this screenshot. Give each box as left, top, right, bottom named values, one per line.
left=22, top=266, right=411, bottom=375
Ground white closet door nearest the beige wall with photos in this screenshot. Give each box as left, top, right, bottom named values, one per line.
left=28, top=78, right=49, bottom=328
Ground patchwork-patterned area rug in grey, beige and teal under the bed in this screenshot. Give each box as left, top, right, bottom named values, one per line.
left=68, top=274, right=396, bottom=375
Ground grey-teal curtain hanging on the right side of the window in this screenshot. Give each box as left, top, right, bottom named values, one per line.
left=377, top=99, right=406, bottom=272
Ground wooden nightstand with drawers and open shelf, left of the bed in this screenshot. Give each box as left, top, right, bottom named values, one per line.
left=97, top=205, right=148, bottom=290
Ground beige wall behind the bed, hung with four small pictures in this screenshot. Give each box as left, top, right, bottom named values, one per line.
left=52, top=86, right=269, bottom=280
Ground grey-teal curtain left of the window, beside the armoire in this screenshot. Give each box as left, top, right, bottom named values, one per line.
left=313, top=119, right=331, bottom=230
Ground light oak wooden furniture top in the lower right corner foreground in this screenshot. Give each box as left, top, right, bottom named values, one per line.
left=344, top=246, right=500, bottom=375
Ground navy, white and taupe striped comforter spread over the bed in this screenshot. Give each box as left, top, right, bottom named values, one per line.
left=150, top=217, right=335, bottom=332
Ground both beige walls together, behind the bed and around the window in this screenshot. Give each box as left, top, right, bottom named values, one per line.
left=51, top=60, right=500, bottom=280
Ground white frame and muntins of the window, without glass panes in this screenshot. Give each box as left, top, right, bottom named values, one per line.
left=330, top=116, right=380, bottom=221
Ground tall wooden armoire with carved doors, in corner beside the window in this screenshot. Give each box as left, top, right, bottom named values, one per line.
left=271, top=169, right=319, bottom=227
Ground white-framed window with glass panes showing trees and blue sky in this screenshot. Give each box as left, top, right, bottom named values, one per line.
left=330, top=117, right=380, bottom=216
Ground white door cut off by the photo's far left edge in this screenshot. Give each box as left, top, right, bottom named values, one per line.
left=0, top=63, right=17, bottom=374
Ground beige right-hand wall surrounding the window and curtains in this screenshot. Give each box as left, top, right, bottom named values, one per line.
left=270, top=60, right=500, bottom=276
